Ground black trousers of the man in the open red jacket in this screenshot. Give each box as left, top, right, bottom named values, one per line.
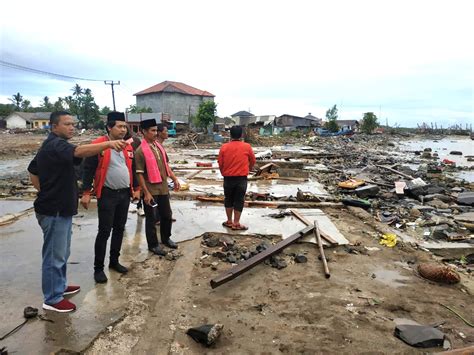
left=94, top=186, right=130, bottom=271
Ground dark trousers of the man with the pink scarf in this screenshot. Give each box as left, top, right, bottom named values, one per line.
left=144, top=195, right=172, bottom=249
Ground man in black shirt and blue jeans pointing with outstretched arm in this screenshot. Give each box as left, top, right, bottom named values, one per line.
left=28, top=111, right=127, bottom=313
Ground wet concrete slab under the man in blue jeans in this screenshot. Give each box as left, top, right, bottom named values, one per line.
left=0, top=201, right=147, bottom=354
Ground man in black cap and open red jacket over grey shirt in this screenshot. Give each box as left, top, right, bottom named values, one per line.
left=81, top=112, right=140, bottom=283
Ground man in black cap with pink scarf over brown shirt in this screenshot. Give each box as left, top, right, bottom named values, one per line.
left=135, top=119, right=180, bottom=256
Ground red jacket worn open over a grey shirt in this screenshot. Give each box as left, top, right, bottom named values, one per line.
left=82, top=136, right=139, bottom=198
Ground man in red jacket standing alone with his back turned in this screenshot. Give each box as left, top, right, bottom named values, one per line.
left=218, top=126, right=255, bottom=230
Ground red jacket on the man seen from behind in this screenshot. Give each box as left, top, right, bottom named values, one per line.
left=217, top=140, right=255, bottom=176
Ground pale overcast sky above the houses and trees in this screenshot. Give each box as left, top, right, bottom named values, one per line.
left=0, top=0, right=474, bottom=126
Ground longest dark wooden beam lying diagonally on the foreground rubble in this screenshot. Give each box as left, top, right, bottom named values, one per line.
left=211, top=226, right=314, bottom=288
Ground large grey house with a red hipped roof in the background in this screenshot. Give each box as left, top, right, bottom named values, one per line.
left=134, top=81, right=215, bottom=123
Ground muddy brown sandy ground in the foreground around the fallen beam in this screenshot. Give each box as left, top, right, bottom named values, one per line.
left=86, top=210, right=474, bottom=354
